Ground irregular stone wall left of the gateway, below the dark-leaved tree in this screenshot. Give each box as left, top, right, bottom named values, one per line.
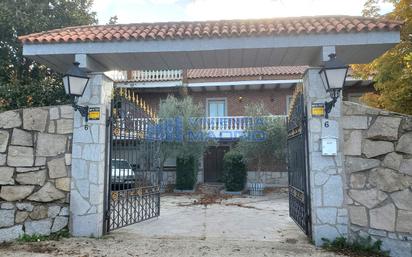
left=0, top=106, right=73, bottom=242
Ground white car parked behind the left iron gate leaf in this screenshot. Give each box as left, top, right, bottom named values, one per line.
left=111, top=159, right=135, bottom=190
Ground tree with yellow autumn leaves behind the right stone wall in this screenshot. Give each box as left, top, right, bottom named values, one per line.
left=352, top=0, right=412, bottom=114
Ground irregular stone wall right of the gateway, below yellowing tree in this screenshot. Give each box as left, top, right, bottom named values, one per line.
left=342, top=102, right=412, bottom=257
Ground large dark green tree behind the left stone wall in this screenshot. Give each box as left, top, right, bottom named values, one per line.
left=0, top=0, right=97, bottom=110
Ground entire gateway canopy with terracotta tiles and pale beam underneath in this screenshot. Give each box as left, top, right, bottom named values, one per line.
left=19, top=16, right=401, bottom=71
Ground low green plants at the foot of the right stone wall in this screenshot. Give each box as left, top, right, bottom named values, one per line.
left=322, top=237, right=389, bottom=257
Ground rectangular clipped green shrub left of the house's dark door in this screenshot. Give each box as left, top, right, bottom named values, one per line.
left=176, top=156, right=197, bottom=190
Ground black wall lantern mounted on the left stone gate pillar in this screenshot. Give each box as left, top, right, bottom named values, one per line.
left=63, top=62, right=89, bottom=130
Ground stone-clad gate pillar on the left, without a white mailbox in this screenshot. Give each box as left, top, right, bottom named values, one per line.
left=70, top=73, right=113, bottom=237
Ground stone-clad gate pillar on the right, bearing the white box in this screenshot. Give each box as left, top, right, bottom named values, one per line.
left=303, top=68, right=348, bottom=245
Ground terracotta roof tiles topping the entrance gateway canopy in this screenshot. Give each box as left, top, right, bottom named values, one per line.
left=19, top=16, right=401, bottom=43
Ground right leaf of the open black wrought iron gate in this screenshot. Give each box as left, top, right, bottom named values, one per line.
left=287, top=86, right=311, bottom=236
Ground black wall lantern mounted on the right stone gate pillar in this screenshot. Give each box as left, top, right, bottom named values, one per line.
left=319, top=54, right=349, bottom=118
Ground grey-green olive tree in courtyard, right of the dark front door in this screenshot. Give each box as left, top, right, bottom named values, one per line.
left=235, top=102, right=287, bottom=182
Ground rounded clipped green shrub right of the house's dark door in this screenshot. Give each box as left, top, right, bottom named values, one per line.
left=223, top=151, right=247, bottom=191
